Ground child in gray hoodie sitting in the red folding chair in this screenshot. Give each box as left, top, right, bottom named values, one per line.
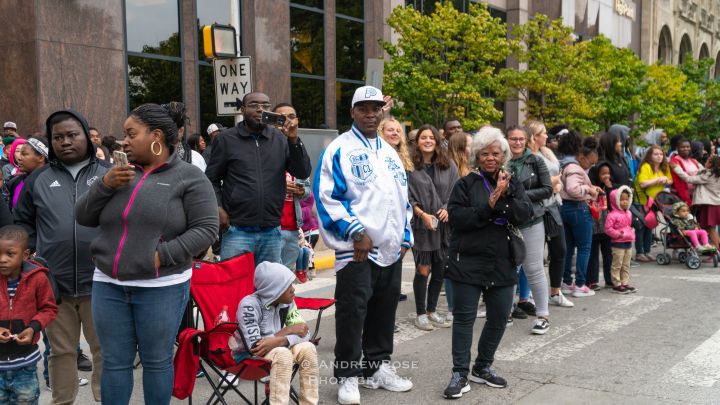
left=233, top=262, right=319, bottom=405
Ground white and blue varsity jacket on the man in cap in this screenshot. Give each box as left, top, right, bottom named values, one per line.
left=313, top=124, right=413, bottom=271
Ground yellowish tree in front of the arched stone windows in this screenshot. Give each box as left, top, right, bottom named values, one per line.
left=635, top=65, right=702, bottom=136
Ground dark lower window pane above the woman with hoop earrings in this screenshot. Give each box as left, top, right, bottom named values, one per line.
left=128, top=56, right=183, bottom=110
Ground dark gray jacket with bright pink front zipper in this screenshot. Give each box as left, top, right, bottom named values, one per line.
left=75, top=153, right=219, bottom=281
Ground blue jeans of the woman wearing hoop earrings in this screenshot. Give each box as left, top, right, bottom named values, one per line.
left=92, top=281, right=190, bottom=405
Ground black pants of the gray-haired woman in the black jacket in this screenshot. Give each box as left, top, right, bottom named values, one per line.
left=452, top=280, right=515, bottom=376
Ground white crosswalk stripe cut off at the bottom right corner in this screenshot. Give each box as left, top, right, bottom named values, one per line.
left=663, top=330, right=720, bottom=387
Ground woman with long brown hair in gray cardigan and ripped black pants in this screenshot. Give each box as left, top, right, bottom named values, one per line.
left=408, top=125, right=460, bottom=330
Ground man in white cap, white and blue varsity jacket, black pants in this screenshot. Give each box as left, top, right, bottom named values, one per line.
left=313, top=86, right=413, bottom=404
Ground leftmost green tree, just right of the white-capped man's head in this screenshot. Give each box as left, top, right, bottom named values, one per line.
left=382, top=1, right=509, bottom=128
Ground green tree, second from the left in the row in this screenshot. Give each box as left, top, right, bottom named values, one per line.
left=500, top=14, right=607, bottom=133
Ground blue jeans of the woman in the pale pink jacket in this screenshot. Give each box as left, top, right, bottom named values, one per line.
left=560, top=200, right=592, bottom=287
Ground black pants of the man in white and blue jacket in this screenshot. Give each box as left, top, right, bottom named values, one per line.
left=333, top=260, right=402, bottom=378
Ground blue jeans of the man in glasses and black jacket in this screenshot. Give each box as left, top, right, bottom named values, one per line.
left=220, top=225, right=282, bottom=265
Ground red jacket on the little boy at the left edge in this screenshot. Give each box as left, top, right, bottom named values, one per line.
left=0, top=261, right=58, bottom=360
